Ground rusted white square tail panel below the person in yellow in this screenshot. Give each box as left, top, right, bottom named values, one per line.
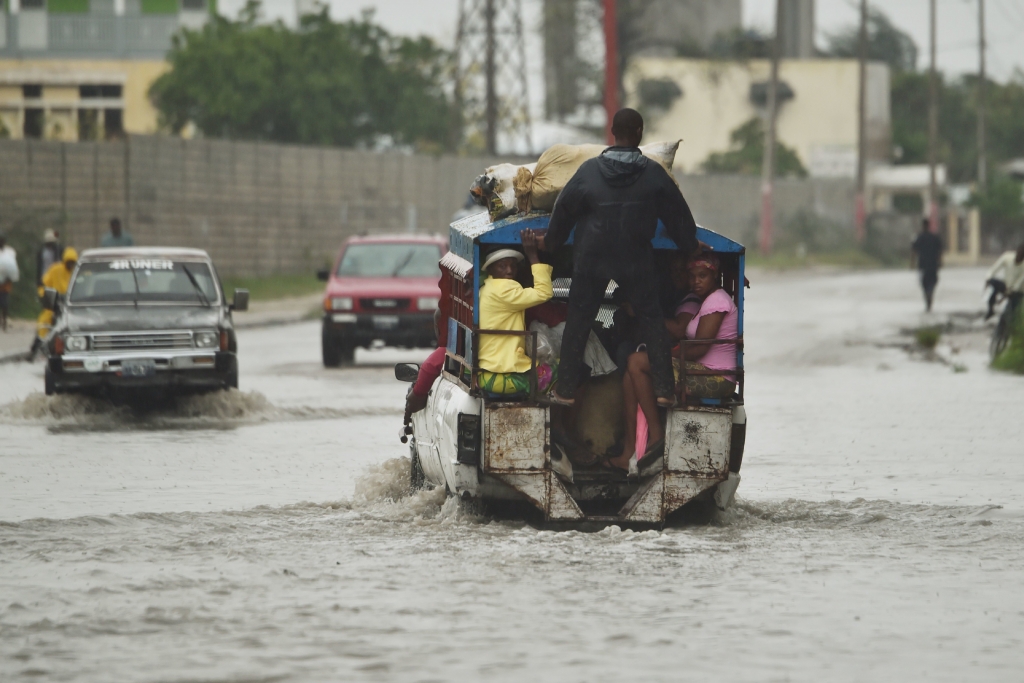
left=483, top=403, right=548, bottom=473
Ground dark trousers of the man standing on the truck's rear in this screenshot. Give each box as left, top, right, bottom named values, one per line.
left=556, top=262, right=675, bottom=398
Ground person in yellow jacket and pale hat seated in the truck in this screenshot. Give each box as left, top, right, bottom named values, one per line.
left=477, top=229, right=553, bottom=394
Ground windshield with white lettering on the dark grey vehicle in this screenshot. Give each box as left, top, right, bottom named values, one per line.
left=68, top=258, right=217, bottom=306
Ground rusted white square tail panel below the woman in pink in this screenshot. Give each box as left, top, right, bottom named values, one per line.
left=666, top=409, right=732, bottom=479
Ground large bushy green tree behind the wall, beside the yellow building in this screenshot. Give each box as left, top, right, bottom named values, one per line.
left=150, top=0, right=453, bottom=148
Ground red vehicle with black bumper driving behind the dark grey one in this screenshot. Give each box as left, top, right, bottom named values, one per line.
left=317, top=234, right=447, bottom=368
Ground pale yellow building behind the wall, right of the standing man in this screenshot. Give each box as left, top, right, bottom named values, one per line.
left=624, top=57, right=891, bottom=177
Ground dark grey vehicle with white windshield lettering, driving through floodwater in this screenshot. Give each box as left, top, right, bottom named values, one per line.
left=45, top=248, right=249, bottom=394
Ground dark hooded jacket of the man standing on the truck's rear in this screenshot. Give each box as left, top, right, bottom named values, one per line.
left=544, top=146, right=697, bottom=270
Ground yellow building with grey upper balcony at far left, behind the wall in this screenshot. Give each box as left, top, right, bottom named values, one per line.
left=0, top=0, right=209, bottom=140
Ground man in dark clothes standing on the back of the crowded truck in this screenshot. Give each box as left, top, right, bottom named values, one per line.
left=544, top=109, right=699, bottom=407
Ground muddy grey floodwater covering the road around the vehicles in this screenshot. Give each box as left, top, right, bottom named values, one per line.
left=0, top=269, right=1024, bottom=682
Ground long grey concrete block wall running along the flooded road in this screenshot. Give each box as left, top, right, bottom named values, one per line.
left=0, top=136, right=854, bottom=274
